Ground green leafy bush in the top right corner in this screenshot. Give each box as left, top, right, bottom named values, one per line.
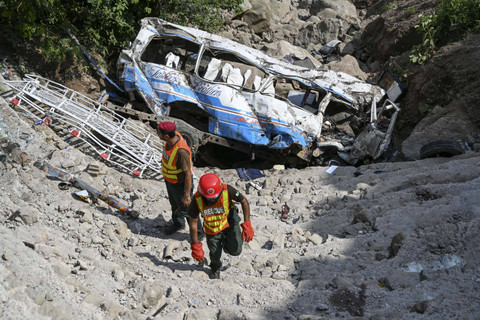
left=410, top=0, right=480, bottom=64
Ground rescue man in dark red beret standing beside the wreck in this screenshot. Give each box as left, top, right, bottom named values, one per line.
left=157, top=121, right=193, bottom=235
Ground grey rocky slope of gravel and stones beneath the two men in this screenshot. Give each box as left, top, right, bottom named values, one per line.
left=0, top=91, right=480, bottom=320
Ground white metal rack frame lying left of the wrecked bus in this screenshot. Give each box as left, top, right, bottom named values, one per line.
left=5, top=75, right=164, bottom=177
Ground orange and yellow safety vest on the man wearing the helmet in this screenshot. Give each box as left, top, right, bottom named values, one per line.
left=195, top=183, right=230, bottom=235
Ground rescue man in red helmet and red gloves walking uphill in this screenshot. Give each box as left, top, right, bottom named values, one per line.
left=188, top=173, right=254, bottom=279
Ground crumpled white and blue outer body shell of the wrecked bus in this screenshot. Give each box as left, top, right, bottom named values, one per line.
left=118, top=18, right=385, bottom=149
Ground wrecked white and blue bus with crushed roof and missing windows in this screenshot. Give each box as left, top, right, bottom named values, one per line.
left=117, top=18, right=399, bottom=166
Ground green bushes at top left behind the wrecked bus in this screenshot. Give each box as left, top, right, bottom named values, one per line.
left=0, top=0, right=242, bottom=65
